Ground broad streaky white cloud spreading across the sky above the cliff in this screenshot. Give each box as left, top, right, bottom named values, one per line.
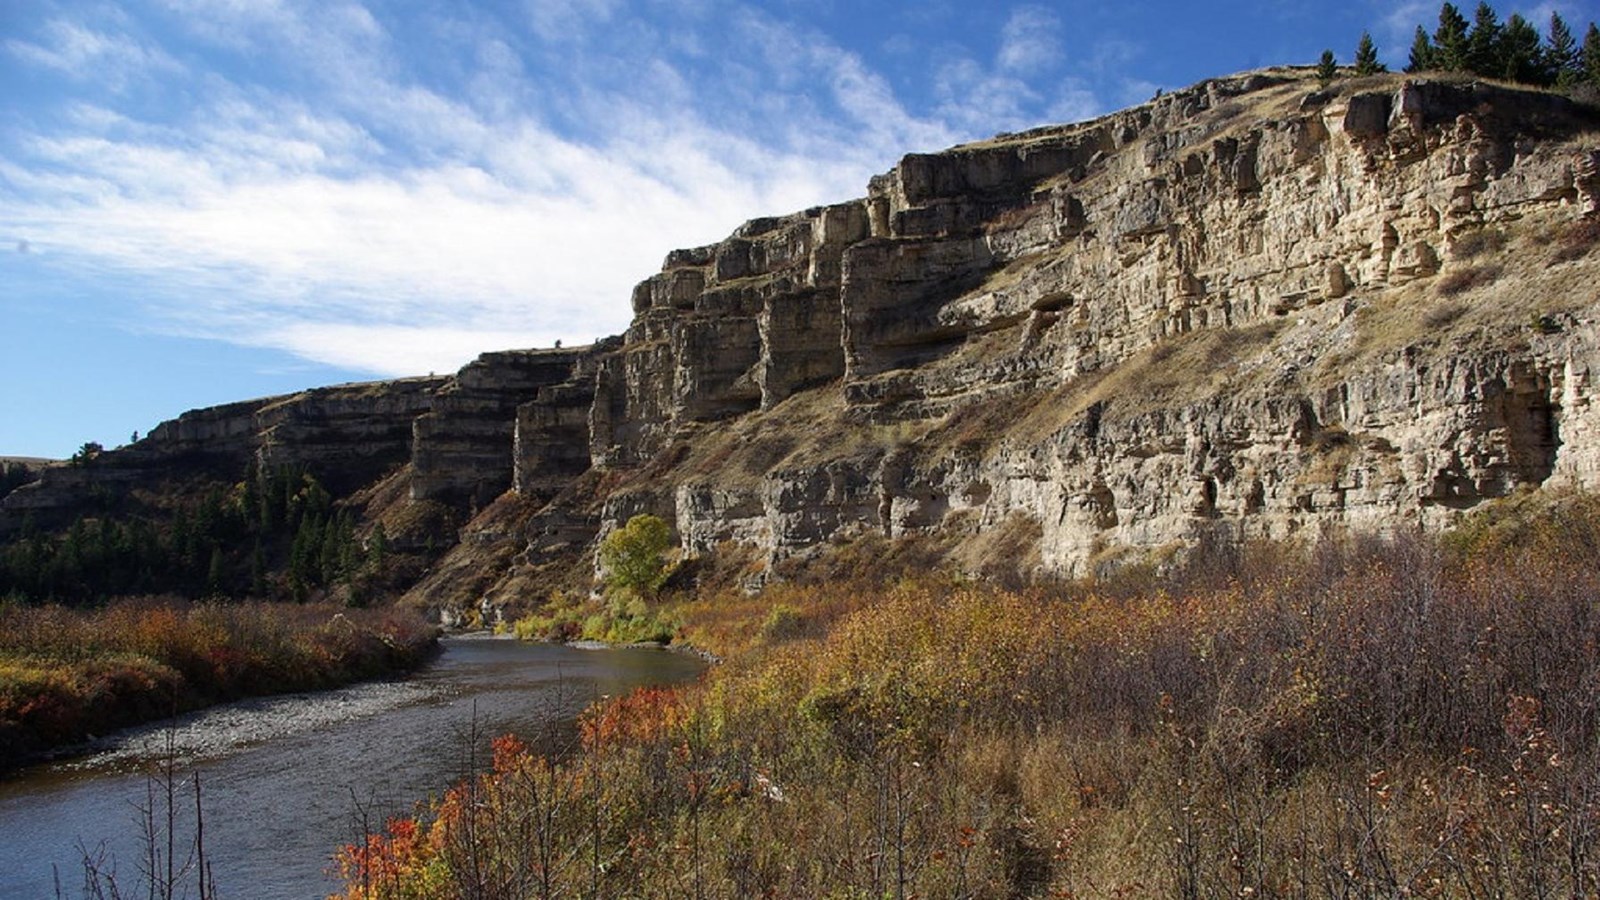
left=0, top=0, right=1120, bottom=375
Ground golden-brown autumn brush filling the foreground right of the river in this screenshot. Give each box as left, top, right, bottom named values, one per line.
left=331, top=496, right=1600, bottom=898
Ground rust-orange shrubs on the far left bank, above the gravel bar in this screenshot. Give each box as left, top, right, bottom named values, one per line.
left=0, top=599, right=438, bottom=772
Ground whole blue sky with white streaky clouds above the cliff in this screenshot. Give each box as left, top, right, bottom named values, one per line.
left=0, top=0, right=1597, bottom=456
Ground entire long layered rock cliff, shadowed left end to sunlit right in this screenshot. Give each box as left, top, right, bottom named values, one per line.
left=3, top=69, right=1600, bottom=593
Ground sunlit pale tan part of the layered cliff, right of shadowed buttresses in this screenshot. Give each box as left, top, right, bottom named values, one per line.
left=582, top=72, right=1600, bottom=572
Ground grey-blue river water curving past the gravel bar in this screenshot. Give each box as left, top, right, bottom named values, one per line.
left=0, top=637, right=702, bottom=900
